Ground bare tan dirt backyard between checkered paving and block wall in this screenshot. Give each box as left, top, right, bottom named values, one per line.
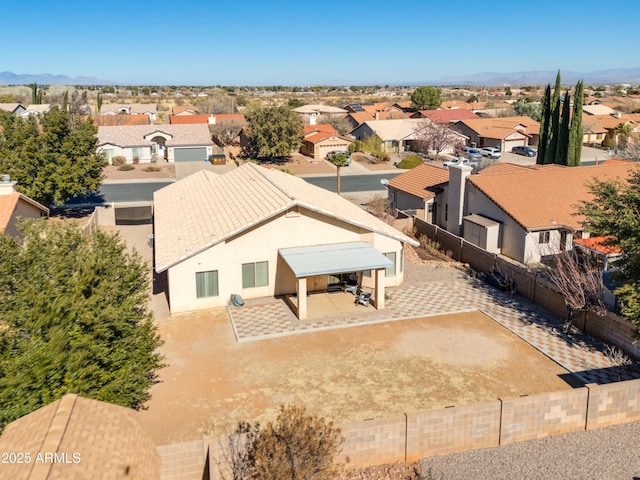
left=139, top=309, right=570, bottom=445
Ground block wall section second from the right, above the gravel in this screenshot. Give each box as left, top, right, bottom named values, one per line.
left=500, top=387, right=589, bottom=445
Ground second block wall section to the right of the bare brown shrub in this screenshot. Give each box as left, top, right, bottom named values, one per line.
left=407, top=400, right=501, bottom=461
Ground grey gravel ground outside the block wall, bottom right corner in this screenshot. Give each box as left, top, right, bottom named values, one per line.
left=420, top=422, right=640, bottom=480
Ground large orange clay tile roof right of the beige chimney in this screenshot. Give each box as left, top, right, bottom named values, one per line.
left=468, top=160, right=636, bottom=231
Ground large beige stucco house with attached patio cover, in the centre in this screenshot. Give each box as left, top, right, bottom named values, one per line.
left=154, top=163, right=417, bottom=319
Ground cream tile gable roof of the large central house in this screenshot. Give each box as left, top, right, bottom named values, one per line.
left=153, top=163, right=416, bottom=272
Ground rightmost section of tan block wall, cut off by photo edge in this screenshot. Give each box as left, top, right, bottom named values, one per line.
left=586, top=380, right=640, bottom=430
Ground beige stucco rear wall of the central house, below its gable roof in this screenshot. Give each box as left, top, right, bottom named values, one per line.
left=168, top=209, right=403, bottom=313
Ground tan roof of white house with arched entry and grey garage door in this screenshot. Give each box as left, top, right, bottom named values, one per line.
left=98, top=124, right=213, bottom=147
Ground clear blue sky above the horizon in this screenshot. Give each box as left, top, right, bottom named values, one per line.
left=0, top=0, right=640, bottom=85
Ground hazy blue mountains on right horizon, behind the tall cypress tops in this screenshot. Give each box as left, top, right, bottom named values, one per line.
left=428, top=68, right=640, bottom=85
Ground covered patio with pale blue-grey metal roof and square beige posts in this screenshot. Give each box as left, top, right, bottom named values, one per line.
left=278, top=242, right=394, bottom=320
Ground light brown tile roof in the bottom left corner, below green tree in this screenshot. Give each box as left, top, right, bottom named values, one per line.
left=0, top=394, right=162, bottom=480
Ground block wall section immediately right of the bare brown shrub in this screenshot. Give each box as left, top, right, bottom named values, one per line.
left=338, top=415, right=407, bottom=467
